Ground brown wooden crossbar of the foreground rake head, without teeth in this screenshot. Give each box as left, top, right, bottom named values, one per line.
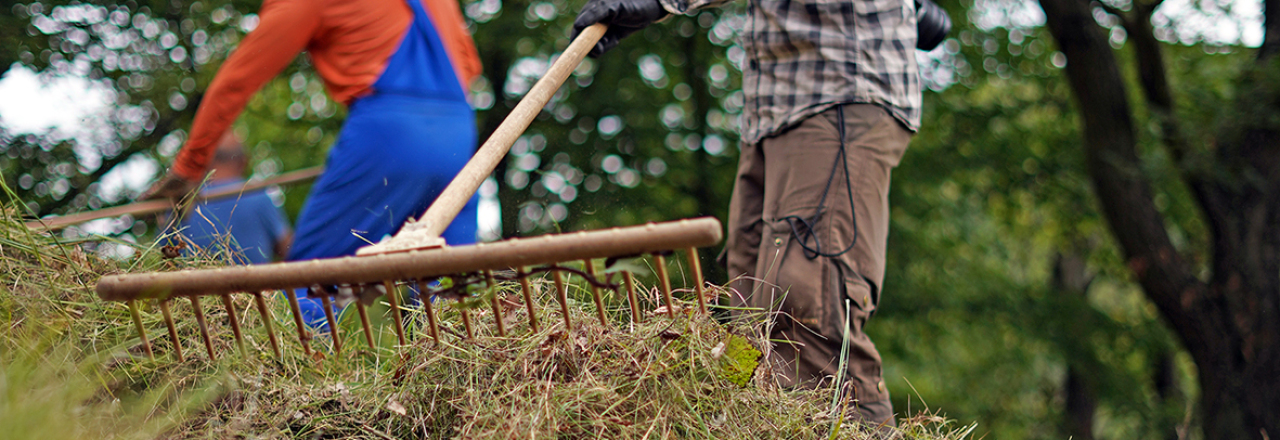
left=95, top=217, right=722, bottom=301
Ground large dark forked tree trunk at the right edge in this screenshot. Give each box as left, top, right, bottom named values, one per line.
left=1041, top=0, right=1280, bottom=440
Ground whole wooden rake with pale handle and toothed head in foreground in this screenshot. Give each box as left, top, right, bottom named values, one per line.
left=96, top=24, right=721, bottom=361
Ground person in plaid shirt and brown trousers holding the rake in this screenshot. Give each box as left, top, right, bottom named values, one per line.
left=573, top=0, right=950, bottom=425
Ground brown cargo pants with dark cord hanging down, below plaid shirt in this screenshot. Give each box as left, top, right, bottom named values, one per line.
left=726, top=104, right=910, bottom=425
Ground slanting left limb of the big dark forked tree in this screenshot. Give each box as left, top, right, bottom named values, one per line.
left=1039, top=0, right=1208, bottom=356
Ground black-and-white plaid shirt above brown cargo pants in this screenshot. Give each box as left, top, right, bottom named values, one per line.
left=659, top=0, right=922, bottom=143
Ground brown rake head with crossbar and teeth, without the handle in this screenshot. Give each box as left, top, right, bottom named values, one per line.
left=96, top=217, right=721, bottom=361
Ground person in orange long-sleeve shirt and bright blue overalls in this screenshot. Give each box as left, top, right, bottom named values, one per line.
left=145, top=0, right=480, bottom=325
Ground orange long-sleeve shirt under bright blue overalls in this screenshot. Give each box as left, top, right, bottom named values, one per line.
left=173, top=0, right=480, bottom=182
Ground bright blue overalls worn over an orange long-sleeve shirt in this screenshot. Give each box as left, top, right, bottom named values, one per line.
left=288, top=0, right=477, bottom=330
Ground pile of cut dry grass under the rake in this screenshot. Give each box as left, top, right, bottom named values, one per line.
left=0, top=205, right=973, bottom=440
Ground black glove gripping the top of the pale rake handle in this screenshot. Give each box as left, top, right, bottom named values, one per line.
left=573, top=0, right=667, bottom=58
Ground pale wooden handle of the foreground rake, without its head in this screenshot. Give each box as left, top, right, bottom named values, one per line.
left=357, top=23, right=607, bottom=255
